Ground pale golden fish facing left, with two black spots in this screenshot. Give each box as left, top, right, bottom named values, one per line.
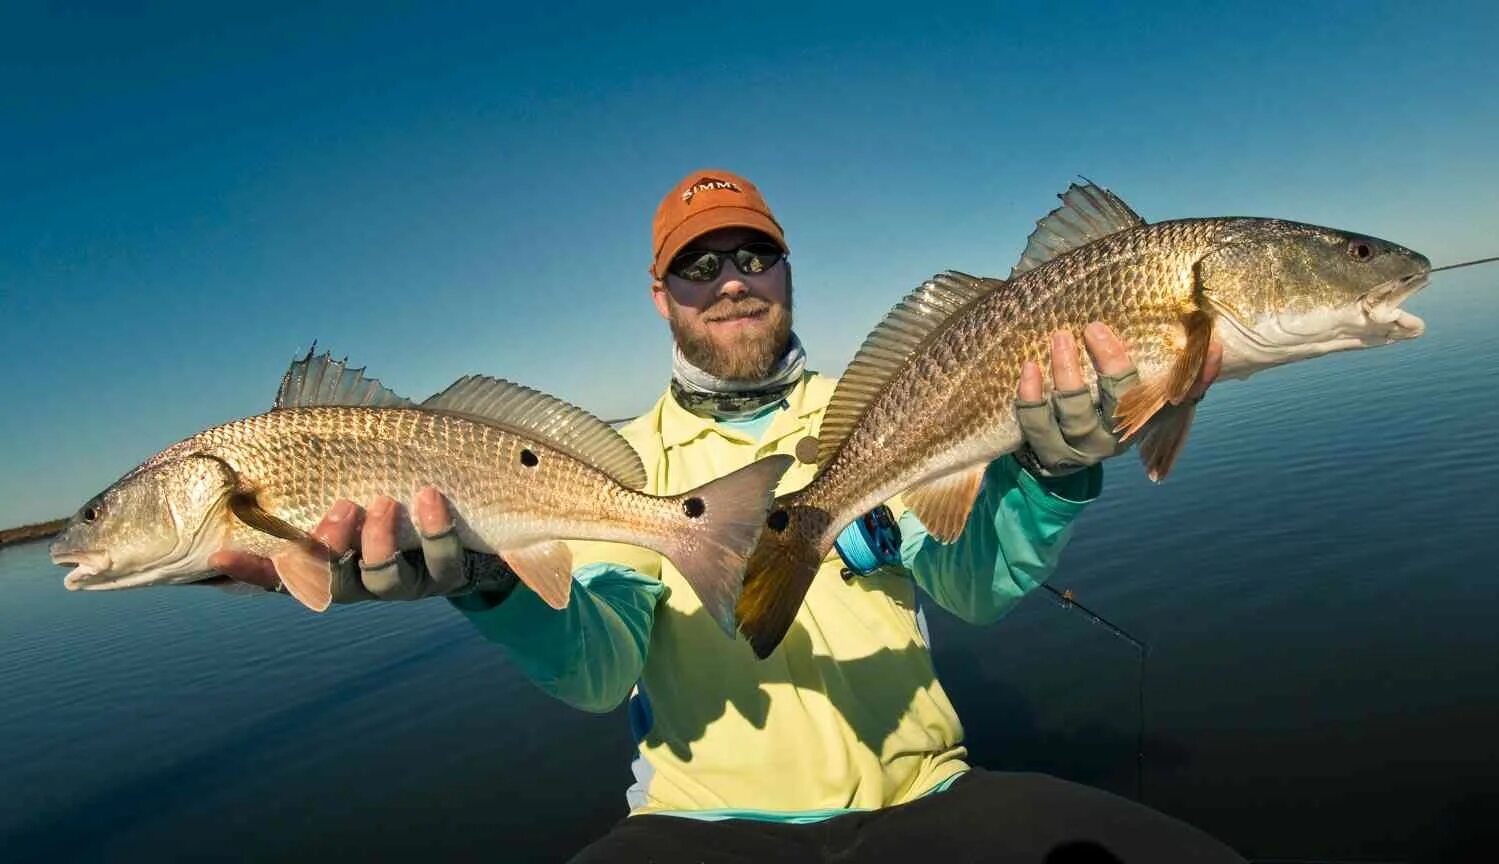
left=51, top=351, right=791, bottom=636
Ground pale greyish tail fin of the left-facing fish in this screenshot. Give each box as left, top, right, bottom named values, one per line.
left=663, top=455, right=794, bottom=636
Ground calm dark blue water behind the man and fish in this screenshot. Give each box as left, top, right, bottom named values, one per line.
left=0, top=270, right=1499, bottom=861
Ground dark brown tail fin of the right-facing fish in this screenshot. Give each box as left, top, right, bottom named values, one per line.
left=735, top=504, right=829, bottom=660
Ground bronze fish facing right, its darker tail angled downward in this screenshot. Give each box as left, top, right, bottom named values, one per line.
left=738, top=185, right=1430, bottom=657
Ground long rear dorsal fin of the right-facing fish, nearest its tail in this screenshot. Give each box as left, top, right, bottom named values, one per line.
left=817, top=270, right=1004, bottom=465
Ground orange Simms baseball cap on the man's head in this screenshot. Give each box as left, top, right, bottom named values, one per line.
left=651, top=170, right=790, bottom=279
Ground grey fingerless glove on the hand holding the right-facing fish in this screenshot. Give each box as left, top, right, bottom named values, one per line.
left=1015, top=368, right=1139, bottom=477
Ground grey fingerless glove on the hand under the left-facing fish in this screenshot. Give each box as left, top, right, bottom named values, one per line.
left=333, top=528, right=516, bottom=605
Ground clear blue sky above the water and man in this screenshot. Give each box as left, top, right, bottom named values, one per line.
left=0, top=2, right=1499, bottom=527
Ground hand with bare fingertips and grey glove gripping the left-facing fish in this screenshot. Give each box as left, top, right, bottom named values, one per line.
left=208, top=486, right=505, bottom=603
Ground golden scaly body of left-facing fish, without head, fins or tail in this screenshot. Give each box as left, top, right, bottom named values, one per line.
left=184, top=408, right=676, bottom=552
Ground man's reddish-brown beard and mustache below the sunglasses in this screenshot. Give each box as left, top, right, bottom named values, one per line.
left=667, top=273, right=791, bottom=381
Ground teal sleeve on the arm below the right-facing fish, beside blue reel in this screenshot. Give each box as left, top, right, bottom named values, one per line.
left=901, top=456, right=1103, bottom=624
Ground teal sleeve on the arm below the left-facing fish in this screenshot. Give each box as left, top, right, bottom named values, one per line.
left=451, top=564, right=667, bottom=713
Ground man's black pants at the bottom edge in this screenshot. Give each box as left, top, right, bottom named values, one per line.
left=573, top=768, right=1244, bottom=864
